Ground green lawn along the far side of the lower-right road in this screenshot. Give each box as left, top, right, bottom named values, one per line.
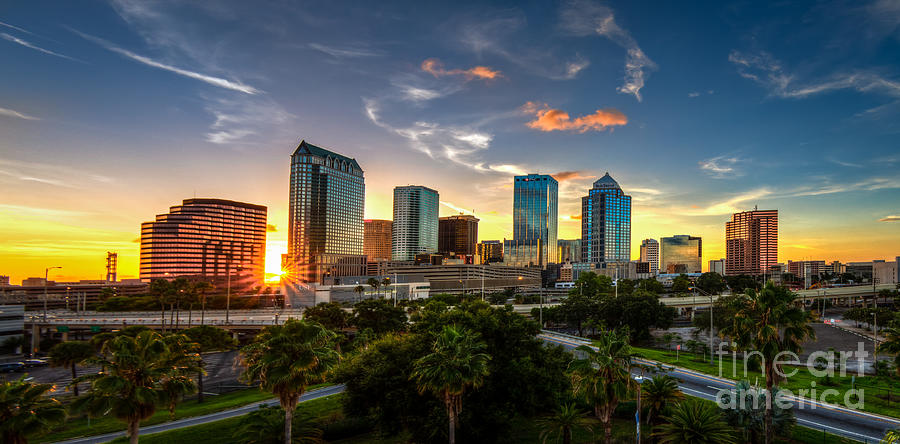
left=634, top=347, right=900, bottom=418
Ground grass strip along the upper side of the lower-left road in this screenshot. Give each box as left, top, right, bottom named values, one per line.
left=35, top=384, right=327, bottom=443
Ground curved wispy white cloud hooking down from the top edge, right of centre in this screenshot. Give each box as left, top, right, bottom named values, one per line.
left=560, top=0, right=656, bottom=102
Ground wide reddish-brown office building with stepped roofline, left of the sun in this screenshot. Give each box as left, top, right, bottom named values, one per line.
left=140, top=199, right=266, bottom=288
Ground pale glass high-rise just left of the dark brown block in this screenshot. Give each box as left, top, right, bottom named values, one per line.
left=391, top=185, right=440, bottom=261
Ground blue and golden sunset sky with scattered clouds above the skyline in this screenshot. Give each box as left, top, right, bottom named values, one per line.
left=0, top=0, right=900, bottom=283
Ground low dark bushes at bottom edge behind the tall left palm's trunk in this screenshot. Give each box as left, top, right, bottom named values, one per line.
left=232, top=406, right=325, bottom=444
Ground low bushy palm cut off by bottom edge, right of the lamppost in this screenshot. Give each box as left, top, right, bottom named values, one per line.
left=653, top=399, right=735, bottom=444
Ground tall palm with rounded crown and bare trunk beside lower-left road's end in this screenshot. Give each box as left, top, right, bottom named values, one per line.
left=241, top=319, right=340, bottom=444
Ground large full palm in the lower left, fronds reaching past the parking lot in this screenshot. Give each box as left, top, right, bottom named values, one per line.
left=72, top=331, right=193, bottom=444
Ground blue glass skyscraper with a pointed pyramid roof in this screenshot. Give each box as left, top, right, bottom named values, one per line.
left=581, top=173, right=631, bottom=265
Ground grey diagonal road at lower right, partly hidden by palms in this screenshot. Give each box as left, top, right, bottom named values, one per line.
left=538, top=334, right=900, bottom=443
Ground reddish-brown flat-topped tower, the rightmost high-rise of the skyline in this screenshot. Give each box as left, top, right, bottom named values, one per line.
left=725, top=210, right=778, bottom=276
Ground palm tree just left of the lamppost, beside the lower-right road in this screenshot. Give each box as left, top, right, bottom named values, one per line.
left=569, top=330, right=637, bottom=443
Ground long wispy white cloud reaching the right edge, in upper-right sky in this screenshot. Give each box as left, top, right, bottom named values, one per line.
left=728, top=50, right=900, bottom=99
